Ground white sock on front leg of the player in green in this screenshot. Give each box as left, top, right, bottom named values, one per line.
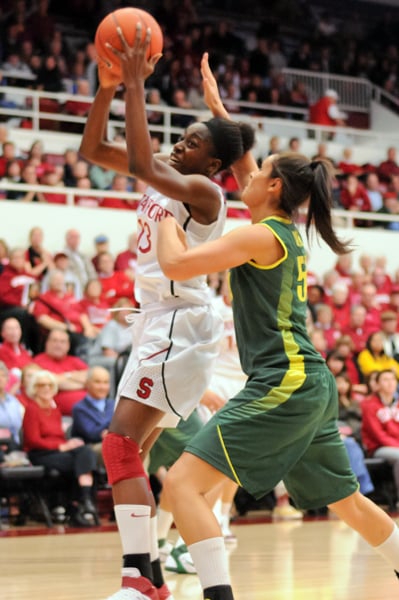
left=188, top=537, right=230, bottom=590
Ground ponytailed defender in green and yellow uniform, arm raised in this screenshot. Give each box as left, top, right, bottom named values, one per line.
left=158, top=51, right=399, bottom=600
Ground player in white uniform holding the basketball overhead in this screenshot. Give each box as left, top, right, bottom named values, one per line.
left=80, top=25, right=253, bottom=600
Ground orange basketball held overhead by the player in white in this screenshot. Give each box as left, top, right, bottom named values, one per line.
left=94, top=7, right=163, bottom=78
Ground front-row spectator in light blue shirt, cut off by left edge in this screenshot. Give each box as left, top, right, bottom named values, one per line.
left=0, top=361, right=23, bottom=451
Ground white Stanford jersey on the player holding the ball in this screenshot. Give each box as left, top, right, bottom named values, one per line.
left=135, top=184, right=226, bottom=307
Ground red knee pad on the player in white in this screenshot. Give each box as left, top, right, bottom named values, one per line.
left=102, top=433, right=147, bottom=485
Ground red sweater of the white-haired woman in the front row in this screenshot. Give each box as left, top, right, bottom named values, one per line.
left=22, top=400, right=66, bottom=452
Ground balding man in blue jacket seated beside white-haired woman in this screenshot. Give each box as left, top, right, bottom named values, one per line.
left=71, top=367, right=115, bottom=468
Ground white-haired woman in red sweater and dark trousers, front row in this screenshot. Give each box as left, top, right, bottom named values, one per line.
left=23, top=370, right=98, bottom=527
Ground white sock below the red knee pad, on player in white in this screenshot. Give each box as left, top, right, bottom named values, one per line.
left=114, top=504, right=151, bottom=554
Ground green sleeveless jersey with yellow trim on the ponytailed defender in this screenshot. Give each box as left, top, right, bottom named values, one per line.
left=230, top=217, right=324, bottom=385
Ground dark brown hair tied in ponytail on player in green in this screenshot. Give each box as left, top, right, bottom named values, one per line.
left=271, top=152, right=352, bottom=254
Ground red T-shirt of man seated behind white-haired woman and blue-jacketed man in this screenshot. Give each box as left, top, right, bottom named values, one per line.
left=32, top=352, right=88, bottom=416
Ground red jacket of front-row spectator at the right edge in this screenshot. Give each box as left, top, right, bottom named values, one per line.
left=361, top=395, right=399, bottom=453
